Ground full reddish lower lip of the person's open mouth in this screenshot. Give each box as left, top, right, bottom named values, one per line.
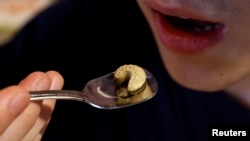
left=154, top=12, right=225, bottom=54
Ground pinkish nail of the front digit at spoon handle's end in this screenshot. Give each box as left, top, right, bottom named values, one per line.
left=9, top=91, right=29, bottom=116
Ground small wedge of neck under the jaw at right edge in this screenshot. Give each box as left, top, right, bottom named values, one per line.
left=225, top=76, right=250, bottom=109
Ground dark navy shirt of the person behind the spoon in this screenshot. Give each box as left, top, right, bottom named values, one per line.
left=0, top=0, right=250, bottom=141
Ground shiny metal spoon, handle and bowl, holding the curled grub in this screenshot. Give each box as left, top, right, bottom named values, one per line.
left=30, top=70, right=158, bottom=109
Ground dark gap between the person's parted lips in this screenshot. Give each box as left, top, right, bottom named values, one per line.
left=165, top=16, right=221, bottom=33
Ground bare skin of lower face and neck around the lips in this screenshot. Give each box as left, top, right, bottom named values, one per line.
left=137, top=0, right=250, bottom=107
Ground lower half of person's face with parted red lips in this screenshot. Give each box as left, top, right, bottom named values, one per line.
left=137, top=0, right=250, bottom=91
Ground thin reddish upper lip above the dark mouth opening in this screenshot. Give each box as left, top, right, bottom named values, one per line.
left=145, top=0, right=222, bottom=23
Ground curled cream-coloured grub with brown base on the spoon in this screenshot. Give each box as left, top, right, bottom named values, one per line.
left=114, top=64, right=153, bottom=105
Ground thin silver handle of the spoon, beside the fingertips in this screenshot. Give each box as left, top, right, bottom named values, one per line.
left=30, top=90, right=87, bottom=101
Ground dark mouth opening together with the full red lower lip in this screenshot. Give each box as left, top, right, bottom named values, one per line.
left=154, top=11, right=225, bottom=54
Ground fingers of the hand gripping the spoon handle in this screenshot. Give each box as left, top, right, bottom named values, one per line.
left=0, top=71, right=64, bottom=141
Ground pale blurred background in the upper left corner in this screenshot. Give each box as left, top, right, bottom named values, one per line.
left=0, top=0, right=56, bottom=46
